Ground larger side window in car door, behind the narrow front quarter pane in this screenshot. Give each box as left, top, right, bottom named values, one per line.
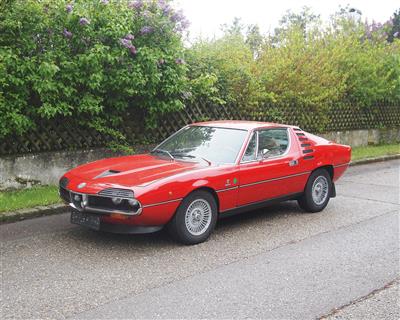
left=258, top=128, right=289, bottom=157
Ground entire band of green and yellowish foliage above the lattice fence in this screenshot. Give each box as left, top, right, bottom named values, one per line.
left=0, top=0, right=400, bottom=139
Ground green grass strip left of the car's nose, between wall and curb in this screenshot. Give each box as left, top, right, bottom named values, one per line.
left=0, top=186, right=61, bottom=212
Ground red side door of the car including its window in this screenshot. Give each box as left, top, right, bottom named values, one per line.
left=238, top=127, right=307, bottom=206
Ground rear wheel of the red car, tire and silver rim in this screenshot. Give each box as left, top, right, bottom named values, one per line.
left=297, top=169, right=332, bottom=212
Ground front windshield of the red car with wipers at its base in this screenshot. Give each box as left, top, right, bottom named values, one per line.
left=153, top=126, right=247, bottom=163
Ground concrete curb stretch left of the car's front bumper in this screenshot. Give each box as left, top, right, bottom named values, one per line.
left=0, top=203, right=68, bottom=224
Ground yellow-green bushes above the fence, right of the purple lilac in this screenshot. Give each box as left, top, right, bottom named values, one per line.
left=188, top=7, right=400, bottom=119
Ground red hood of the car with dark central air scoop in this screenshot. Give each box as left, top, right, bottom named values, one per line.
left=68, top=154, right=203, bottom=187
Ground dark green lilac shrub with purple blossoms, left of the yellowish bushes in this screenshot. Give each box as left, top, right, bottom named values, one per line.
left=0, top=0, right=190, bottom=138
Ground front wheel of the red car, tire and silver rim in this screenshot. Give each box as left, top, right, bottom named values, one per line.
left=167, top=190, right=218, bottom=245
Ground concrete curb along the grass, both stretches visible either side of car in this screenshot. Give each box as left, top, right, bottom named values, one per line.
left=0, top=154, right=400, bottom=224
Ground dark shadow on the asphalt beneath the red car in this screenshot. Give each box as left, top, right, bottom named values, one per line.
left=68, top=201, right=304, bottom=249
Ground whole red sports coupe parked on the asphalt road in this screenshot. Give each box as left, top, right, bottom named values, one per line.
left=60, top=121, right=351, bottom=244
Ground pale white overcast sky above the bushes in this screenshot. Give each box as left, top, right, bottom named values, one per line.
left=174, top=0, right=400, bottom=39
